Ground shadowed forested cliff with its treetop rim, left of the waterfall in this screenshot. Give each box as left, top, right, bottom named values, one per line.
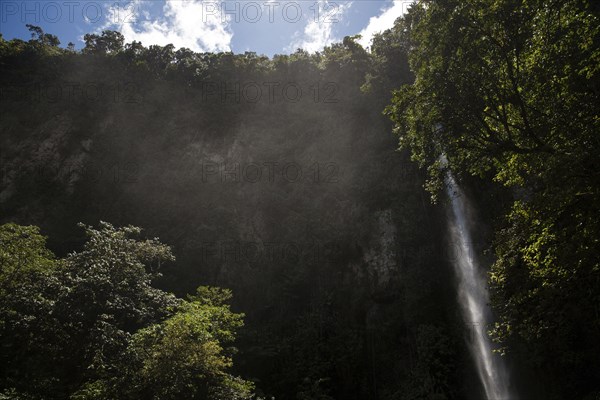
left=0, top=21, right=466, bottom=400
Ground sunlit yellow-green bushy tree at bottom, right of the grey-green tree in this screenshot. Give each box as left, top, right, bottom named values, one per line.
left=76, top=298, right=253, bottom=400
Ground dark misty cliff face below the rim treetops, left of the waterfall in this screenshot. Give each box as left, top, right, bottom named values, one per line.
left=0, top=50, right=466, bottom=399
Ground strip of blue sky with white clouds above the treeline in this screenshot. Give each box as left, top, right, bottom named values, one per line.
left=0, top=0, right=410, bottom=56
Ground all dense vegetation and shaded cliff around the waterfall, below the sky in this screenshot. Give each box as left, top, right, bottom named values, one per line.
left=0, top=0, right=600, bottom=400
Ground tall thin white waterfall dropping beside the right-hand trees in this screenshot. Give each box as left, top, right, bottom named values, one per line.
left=446, top=174, right=514, bottom=400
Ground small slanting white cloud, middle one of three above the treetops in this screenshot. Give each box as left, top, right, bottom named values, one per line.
left=286, top=0, right=352, bottom=53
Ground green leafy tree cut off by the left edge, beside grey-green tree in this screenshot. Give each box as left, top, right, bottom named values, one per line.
left=0, top=223, right=63, bottom=399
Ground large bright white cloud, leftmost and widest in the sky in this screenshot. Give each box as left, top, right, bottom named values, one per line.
left=102, top=0, right=233, bottom=52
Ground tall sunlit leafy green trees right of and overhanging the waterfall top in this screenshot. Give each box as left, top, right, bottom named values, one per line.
left=387, top=0, right=600, bottom=398
